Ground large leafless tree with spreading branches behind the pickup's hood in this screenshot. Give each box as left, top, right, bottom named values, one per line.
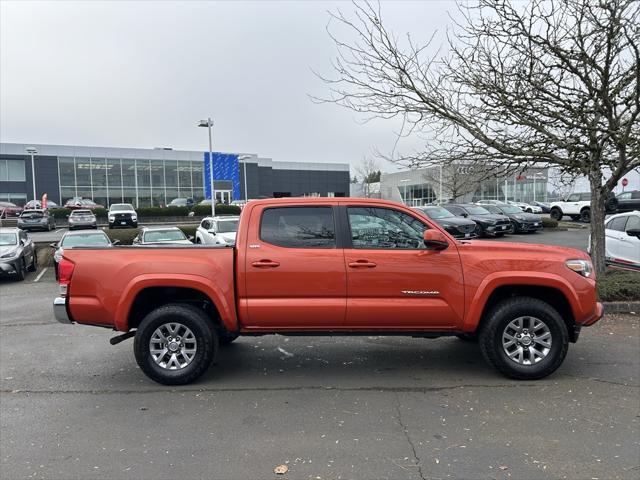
left=322, top=0, right=640, bottom=273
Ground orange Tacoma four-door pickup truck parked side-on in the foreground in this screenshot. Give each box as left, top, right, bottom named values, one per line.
left=54, top=198, right=602, bottom=385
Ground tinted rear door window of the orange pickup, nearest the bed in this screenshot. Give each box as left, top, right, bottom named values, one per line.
left=260, top=207, right=336, bottom=248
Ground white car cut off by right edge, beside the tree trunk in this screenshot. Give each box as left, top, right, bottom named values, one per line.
left=589, top=210, right=640, bottom=270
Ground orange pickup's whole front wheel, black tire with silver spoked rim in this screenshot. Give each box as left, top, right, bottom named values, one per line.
left=480, top=297, right=569, bottom=380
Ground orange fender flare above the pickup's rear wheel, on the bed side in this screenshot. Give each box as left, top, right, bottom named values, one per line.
left=114, top=274, right=237, bottom=332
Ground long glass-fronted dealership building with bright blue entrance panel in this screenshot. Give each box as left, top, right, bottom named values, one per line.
left=0, top=143, right=350, bottom=207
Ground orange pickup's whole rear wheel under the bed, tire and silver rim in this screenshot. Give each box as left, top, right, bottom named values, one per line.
left=133, top=304, right=218, bottom=385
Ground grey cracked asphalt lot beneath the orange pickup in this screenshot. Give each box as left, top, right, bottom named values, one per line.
left=0, top=223, right=640, bottom=479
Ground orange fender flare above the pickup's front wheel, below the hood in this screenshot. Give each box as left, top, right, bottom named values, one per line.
left=462, top=271, right=580, bottom=331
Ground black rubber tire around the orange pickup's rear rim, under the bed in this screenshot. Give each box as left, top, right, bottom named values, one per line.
left=133, top=304, right=218, bottom=385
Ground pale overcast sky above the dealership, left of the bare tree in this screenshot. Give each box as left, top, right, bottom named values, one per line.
left=0, top=1, right=456, bottom=171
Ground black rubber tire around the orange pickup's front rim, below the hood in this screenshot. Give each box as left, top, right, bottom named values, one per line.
left=479, top=297, right=569, bottom=380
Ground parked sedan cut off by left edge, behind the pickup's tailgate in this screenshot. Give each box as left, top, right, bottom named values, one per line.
left=0, top=228, right=38, bottom=280
